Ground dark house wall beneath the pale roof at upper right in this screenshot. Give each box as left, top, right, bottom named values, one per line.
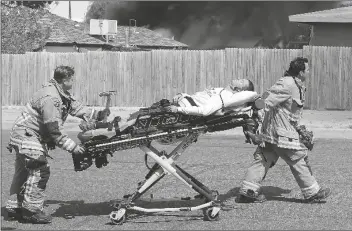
left=309, top=23, right=352, bottom=47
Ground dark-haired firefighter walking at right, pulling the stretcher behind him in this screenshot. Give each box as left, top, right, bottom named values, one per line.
left=236, top=57, right=331, bottom=203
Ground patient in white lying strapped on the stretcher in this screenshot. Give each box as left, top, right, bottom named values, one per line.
left=78, top=79, right=259, bottom=142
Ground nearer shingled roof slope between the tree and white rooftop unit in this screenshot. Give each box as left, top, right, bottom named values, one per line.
left=39, top=12, right=106, bottom=45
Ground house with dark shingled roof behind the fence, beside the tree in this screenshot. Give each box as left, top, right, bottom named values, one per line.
left=41, top=16, right=188, bottom=52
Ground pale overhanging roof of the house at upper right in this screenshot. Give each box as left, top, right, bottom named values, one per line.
left=288, top=6, right=352, bottom=23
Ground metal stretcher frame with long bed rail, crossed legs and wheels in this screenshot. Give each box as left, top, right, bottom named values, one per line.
left=78, top=102, right=262, bottom=225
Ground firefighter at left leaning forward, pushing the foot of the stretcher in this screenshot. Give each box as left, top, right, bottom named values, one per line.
left=6, top=66, right=110, bottom=224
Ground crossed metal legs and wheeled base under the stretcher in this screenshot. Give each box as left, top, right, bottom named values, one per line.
left=110, top=133, right=220, bottom=224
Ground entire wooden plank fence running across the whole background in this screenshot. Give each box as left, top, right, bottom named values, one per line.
left=2, top=47, right=352, bottom=110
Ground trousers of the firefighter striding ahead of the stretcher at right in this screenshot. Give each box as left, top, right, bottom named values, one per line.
left=240, top=143, right=320, bottom=198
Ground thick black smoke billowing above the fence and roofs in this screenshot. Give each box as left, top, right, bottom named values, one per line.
left=93, top=1, right=350, bottom=49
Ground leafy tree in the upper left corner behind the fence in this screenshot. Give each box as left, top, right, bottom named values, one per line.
left=1, top=4, right=50, bottom=54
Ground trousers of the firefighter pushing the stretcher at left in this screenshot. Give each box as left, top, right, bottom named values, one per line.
left=6, top=148, right=50, bottom=212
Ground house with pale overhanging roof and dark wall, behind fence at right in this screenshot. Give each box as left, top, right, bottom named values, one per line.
left=289, top=6, right=352, bottom=46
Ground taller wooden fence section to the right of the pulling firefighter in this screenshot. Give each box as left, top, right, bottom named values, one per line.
left=303, top=46, right=352, bottom=110
